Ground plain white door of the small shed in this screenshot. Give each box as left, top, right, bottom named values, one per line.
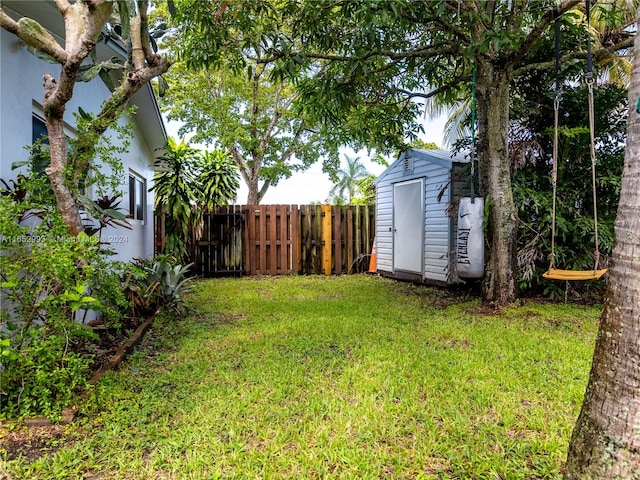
left=393, top=179, right=424, bottom=274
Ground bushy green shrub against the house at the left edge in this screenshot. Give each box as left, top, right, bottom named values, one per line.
left=0, top=176, right=128, bottom=417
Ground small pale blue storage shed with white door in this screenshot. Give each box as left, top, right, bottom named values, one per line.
left=376, top=149, right=470, bottom=285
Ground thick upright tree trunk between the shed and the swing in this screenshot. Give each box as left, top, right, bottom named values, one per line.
left=477, top=58, right=518, bottom=306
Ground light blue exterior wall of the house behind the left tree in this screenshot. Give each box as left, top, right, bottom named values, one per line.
left=0, top=26, right=155, bottom=260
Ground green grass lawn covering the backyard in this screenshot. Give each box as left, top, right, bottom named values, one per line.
left=0, top=275, right=600, bottom=480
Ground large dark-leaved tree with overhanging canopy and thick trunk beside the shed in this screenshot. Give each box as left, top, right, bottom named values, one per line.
left=174, top=0, right=634, bottom=305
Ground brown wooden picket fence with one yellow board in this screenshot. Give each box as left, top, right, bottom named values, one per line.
left=155, top=205, right=375, bottom=277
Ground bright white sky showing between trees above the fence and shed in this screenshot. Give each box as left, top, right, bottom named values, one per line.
left=165, top=117, right=447, bottom=205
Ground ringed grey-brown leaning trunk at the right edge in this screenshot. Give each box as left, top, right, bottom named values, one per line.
left=564, top=11, right=640, bottom=480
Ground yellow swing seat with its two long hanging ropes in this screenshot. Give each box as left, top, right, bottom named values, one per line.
left=542, top=0, right=607, bottom=280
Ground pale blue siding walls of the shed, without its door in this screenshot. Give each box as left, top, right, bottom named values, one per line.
left=376, top=150, right=462, bottom=285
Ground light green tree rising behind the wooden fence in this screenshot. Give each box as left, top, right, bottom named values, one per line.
left=162, top=2, right=339, bottom=204
